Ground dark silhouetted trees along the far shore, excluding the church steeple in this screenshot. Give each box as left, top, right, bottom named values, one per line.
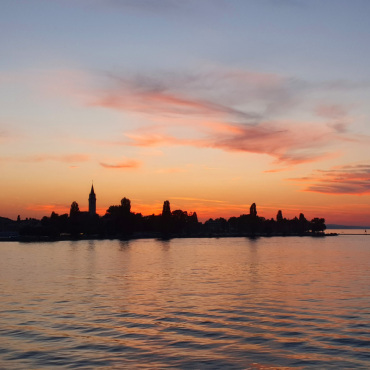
left=18, top=198, right=326, bottom=239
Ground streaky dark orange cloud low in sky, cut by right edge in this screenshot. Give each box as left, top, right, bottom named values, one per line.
left=290, top=164, right=370, bottom=195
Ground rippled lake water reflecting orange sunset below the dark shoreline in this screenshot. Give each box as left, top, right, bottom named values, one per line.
left=0, top=235, right=370, bottom=369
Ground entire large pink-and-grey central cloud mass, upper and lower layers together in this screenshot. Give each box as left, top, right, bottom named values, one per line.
left=83, top=70, right=368, bottom=164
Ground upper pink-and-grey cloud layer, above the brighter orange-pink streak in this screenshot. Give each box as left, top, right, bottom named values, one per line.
left=90, top=70, right=297, bottom=123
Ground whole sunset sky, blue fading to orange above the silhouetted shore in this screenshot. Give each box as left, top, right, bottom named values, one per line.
left=0, top=0, right=370, bottom=226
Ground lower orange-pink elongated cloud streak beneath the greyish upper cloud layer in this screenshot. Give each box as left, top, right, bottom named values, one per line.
left=122, top=122, right=342, bottom=164
